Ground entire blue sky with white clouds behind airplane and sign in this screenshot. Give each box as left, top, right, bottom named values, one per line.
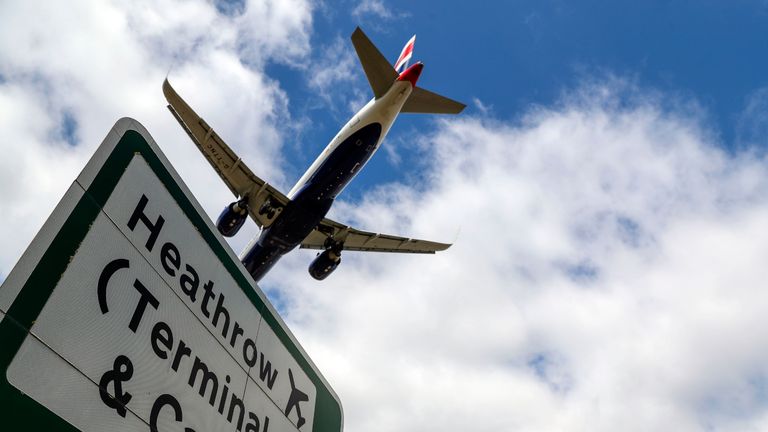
left=0, top=0, right=768, bottom=431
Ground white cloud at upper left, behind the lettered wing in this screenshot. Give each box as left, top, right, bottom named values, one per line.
left=0, top=0, right=312, bottom=273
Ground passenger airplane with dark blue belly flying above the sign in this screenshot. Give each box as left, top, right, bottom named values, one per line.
left=163, top=27, right=465, bottom=281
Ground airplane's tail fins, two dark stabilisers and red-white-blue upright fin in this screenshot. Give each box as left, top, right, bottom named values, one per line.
left=352, top=27, right=466, bottom=114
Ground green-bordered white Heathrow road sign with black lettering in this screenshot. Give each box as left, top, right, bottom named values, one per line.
left=0, top=119, right=342, bottom=432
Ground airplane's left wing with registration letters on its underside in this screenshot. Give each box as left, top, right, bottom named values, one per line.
left=163, top=79, right=290, bottom=228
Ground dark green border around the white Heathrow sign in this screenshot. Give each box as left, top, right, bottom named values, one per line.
left=0, top=129, right=342, bottom=432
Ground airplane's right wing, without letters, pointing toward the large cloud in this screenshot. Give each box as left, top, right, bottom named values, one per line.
left=301, top=218, right=451, bottom=254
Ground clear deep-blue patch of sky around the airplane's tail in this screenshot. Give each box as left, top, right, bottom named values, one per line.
left=267, top=1, right=768, bottom=199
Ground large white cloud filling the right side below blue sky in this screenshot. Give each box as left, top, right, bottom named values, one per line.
left=265, top=79, right=768, bottom=431
